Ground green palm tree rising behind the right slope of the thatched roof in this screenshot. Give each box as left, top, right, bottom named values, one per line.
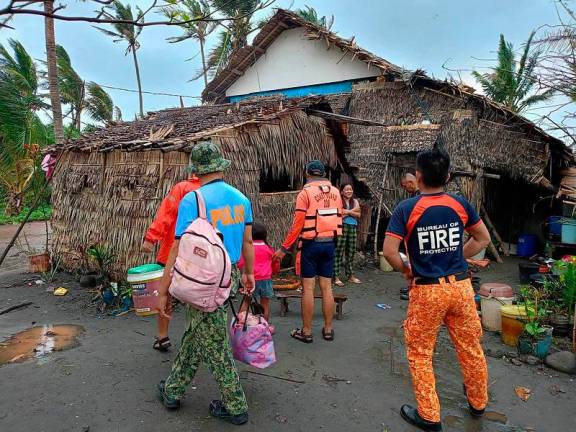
left=472, top=32, right=554, bottom=113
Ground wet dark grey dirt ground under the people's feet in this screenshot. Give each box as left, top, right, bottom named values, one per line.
left=0, top=260, right=576, bottom=432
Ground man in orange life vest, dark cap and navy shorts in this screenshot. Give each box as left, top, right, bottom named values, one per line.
left=274, top=160, right=342, bottom=343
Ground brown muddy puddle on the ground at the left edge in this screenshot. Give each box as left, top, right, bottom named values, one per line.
left=0, top=324, right=84, bottom=366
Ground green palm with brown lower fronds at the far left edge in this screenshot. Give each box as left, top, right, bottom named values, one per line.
left=0, top=39, right=50, bottom=214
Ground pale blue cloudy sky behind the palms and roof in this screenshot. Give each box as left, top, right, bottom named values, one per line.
left=0, top=0, right=558, bottom=123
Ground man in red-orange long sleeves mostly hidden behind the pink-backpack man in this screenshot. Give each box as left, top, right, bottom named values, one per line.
left=142, top=176, right=200, bottom=351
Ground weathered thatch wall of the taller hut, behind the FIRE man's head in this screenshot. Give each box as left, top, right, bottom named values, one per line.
left=347, top=81, right=550, bottom=213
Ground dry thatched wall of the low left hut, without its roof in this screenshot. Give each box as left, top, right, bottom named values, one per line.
left=53, top=106, right=337, bottom=274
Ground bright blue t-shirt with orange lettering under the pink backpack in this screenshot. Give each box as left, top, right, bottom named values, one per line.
left=176, top=180, right=253, bottom=264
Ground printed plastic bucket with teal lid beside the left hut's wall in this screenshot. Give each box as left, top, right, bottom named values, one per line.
left=127, top=264, right=164, bottom=316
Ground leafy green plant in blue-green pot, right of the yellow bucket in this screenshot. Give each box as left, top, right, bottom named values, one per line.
left=518, top=286, right=553, bottom=359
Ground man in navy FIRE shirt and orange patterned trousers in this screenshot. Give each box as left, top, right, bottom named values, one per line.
left=383, top=148, right=490, bottom=431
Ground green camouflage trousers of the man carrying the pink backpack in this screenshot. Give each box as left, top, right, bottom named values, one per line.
left=165, top=268, right=248, bottom=415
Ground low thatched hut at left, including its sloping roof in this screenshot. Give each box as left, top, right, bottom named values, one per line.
left=52, top=96, right=341, bottom=271
